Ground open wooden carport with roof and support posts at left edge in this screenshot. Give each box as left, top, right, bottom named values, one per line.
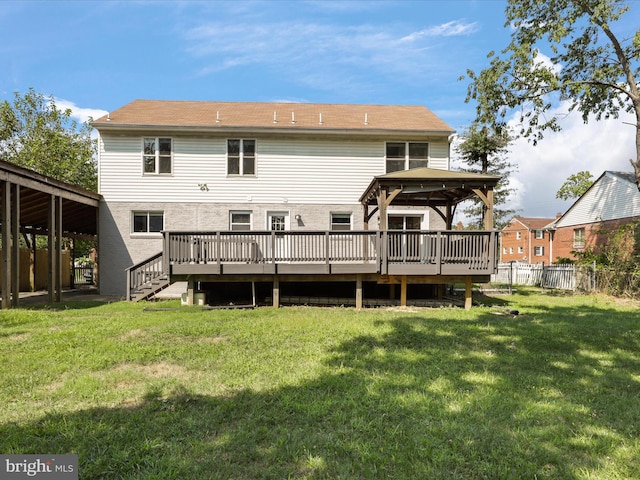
left=0, top=160, right=102, bottom=309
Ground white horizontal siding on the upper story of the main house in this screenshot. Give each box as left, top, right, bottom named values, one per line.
left=100, top=135, right=385, bottom=204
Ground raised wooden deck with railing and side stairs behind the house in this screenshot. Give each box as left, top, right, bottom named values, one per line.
left=127, top=230, right=498, bottom=308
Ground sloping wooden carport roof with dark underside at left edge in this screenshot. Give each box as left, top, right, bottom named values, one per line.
left=0, top=160, right=102, bottom=237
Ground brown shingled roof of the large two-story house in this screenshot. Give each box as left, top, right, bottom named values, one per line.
left=93, top=100, right=455, bottom=134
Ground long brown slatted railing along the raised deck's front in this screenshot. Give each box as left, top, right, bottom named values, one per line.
left=164, top=230, right=498, bottom=275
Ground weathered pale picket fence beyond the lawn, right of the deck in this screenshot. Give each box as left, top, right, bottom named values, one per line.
left=491, top=262, right=593, bottom=290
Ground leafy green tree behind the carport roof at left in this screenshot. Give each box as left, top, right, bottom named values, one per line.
left=0, top=89, right=97, bottom=191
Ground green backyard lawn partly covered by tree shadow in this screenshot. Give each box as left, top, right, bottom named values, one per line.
left=0, top=290, right=640, bottom=480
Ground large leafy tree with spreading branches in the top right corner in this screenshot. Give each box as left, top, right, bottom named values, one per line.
left=467, top=0, right=640, bottom=189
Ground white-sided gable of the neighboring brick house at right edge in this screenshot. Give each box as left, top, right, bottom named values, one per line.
left=552, top=171, right=640, bottom=228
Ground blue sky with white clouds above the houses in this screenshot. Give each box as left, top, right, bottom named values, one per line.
left=0, top=0, right=633, bottom=216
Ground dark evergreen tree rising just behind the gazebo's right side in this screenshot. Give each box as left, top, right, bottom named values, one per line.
left=455, top=124, right=515, bottom=229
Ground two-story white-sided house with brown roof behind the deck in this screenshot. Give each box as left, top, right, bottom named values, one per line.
left=93, top=100, right=497, bottom=308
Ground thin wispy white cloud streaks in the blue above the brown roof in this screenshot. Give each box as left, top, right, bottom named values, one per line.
left=184, top=17, right=476, bottom=88
